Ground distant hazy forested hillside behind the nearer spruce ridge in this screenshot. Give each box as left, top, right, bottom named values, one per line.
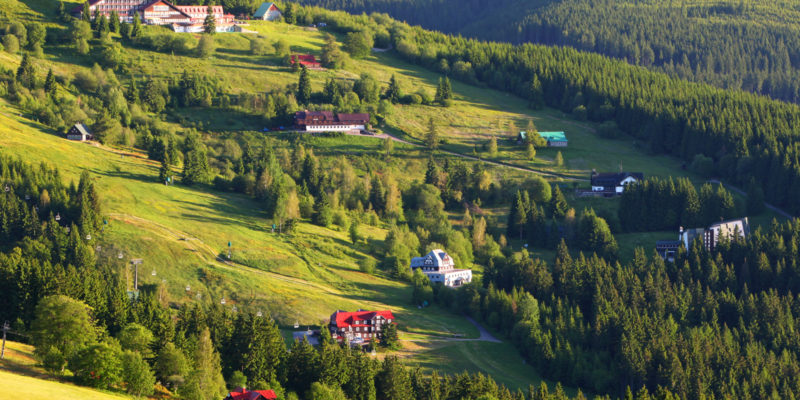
left=294, top=0, right=800, bottom=102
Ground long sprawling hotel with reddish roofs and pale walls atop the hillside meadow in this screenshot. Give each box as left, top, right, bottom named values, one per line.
left=73, top=0, right=234, bottom=32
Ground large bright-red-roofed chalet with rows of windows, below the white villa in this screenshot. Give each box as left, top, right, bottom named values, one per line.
left=328, top=310, right=394, bottom=342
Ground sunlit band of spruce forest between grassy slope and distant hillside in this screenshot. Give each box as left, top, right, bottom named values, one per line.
left=290, top=3, right=800, bottom=213
